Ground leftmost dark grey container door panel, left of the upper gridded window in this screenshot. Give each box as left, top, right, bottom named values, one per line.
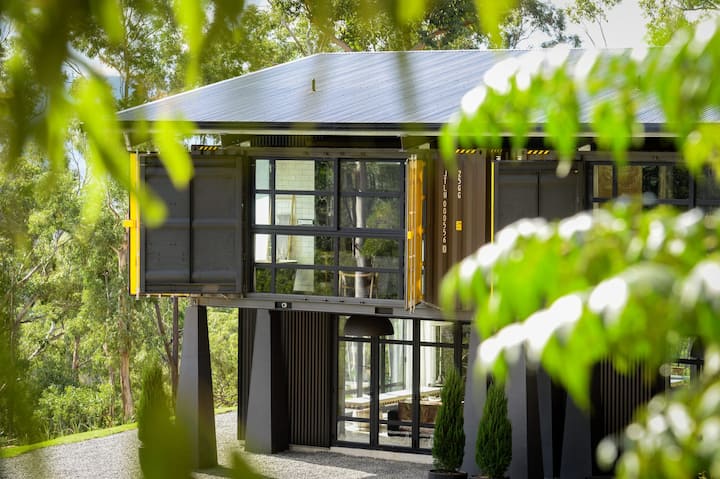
left=140, top=155, right=246, bottom=293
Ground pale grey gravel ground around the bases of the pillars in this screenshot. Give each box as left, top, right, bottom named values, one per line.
left=0, top=412, right=429, bottom=479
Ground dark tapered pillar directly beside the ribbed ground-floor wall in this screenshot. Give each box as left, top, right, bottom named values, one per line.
left=245, top=309, right=290, bottom=454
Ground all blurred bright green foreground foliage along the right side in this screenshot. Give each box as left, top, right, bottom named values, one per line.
left=442, top=18, right=720, bottom=477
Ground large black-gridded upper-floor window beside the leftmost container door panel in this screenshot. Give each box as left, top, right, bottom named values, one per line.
left=252, top=158, right=405, bottom=299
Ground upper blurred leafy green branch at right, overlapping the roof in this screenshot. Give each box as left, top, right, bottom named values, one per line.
left=441, top=22, right=720, bottom=176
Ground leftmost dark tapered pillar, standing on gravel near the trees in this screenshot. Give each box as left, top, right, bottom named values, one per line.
left=175, top=305, right=217, bottom=469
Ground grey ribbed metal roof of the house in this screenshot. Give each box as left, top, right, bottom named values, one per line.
left=118, top=50, right=716, bottom=134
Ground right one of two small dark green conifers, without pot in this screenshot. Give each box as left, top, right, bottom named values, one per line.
left=475, top=383, right=512, bottom=479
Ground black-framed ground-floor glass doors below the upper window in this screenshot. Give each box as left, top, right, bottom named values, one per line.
left=335, top=317, right=469, bottom=451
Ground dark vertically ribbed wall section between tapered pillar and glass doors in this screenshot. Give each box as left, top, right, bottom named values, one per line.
left=281, top=311, right=333, bottom=447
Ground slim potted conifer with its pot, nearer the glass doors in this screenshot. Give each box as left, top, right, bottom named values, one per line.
left=428, top=368, right=467, bottom=479
